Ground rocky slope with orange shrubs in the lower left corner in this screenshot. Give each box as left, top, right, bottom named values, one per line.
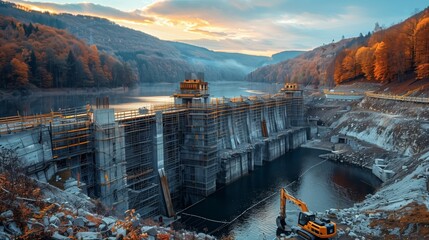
left=0, top=159, right=214, bottom=240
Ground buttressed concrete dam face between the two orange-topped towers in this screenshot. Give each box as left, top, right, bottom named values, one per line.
left=217, top=98, right=308, bottom=187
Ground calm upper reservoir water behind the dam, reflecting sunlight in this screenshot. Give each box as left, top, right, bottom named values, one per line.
left=0, top=81, right=282, bottom=117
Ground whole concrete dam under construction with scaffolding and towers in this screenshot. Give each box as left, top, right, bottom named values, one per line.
left=0, top=77, right=310, bottom=218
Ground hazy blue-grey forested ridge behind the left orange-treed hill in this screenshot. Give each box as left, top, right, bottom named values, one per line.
left=0, top=1, right=300, bottom=82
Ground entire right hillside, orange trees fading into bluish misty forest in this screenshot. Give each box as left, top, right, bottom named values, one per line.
left=247, top=9, right=429, bottom=93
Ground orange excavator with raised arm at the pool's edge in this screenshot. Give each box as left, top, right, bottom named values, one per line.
left=276, top=188, right=337, bottom=240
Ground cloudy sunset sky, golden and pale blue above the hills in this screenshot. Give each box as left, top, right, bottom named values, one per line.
left=10, top=0, right=429, bottom=56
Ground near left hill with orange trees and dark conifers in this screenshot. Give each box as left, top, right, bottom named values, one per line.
left=0, top=16, right=135, bottom=89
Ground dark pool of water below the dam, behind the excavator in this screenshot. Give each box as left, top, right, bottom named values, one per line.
left=182, top=148, right=381, bottom=239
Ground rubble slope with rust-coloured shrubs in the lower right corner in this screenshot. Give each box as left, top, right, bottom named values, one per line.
left=320, top=152, right=429, bottom=239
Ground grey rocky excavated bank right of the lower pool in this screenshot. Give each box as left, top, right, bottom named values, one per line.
left=308, top=84, right=429, bottom=239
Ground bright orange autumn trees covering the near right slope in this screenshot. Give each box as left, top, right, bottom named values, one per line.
left=334, top=9, right=429, bottom=84
